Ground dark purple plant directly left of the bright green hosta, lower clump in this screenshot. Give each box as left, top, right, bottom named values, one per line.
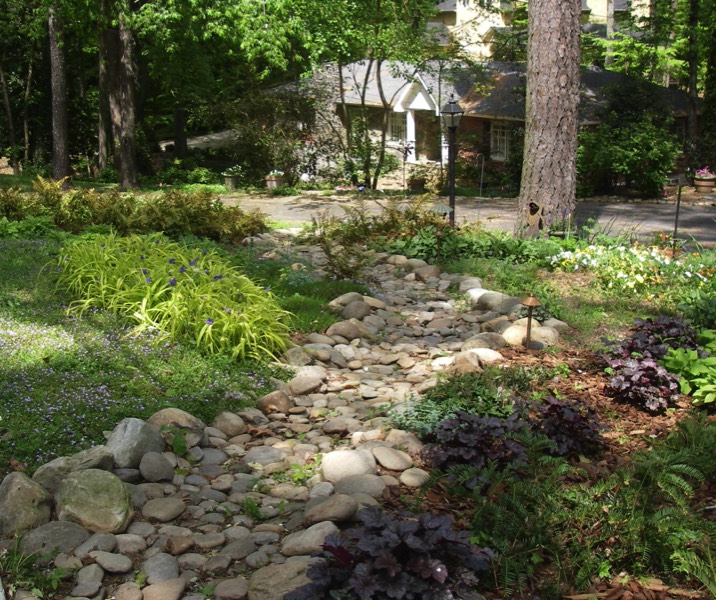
left=609, top=358, right=679, bottom=412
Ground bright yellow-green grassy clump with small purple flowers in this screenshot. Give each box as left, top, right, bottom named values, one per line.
left=57, top=234, right=288, bottom=360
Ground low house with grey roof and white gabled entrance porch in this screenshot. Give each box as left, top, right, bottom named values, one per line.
left=328, top=61, right=689, bottom=176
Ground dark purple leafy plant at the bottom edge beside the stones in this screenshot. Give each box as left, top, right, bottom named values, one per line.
left=284, top=507, right=493, bottom=600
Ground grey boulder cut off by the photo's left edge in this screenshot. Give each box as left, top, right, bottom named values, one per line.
left=0, top=472, right=52, bottom=537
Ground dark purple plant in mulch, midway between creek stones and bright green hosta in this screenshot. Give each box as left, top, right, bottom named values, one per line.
left=530, top=396, right=606, bottom=456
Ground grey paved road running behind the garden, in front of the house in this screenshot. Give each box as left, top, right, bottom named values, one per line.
left=225, top=192, right=716, bottom=247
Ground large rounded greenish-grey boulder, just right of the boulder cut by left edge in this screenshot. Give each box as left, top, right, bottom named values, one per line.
left=55, top=469, right=134, bottom=533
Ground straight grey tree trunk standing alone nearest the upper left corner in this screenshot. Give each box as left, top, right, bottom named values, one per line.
left=48, top=7, right=71, bottom=181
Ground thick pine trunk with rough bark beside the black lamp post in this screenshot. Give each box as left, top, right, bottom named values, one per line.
left=517, top=0, right=581, bottom=237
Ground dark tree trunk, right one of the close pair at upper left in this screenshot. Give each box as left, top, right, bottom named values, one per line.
left=119, top=12, right=137, bottom=189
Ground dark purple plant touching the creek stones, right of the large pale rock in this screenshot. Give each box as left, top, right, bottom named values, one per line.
left=426, top=411, right=527, bottom=476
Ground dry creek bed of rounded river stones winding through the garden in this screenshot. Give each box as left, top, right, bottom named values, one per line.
left=0, top=232, right=566, bottom=600
